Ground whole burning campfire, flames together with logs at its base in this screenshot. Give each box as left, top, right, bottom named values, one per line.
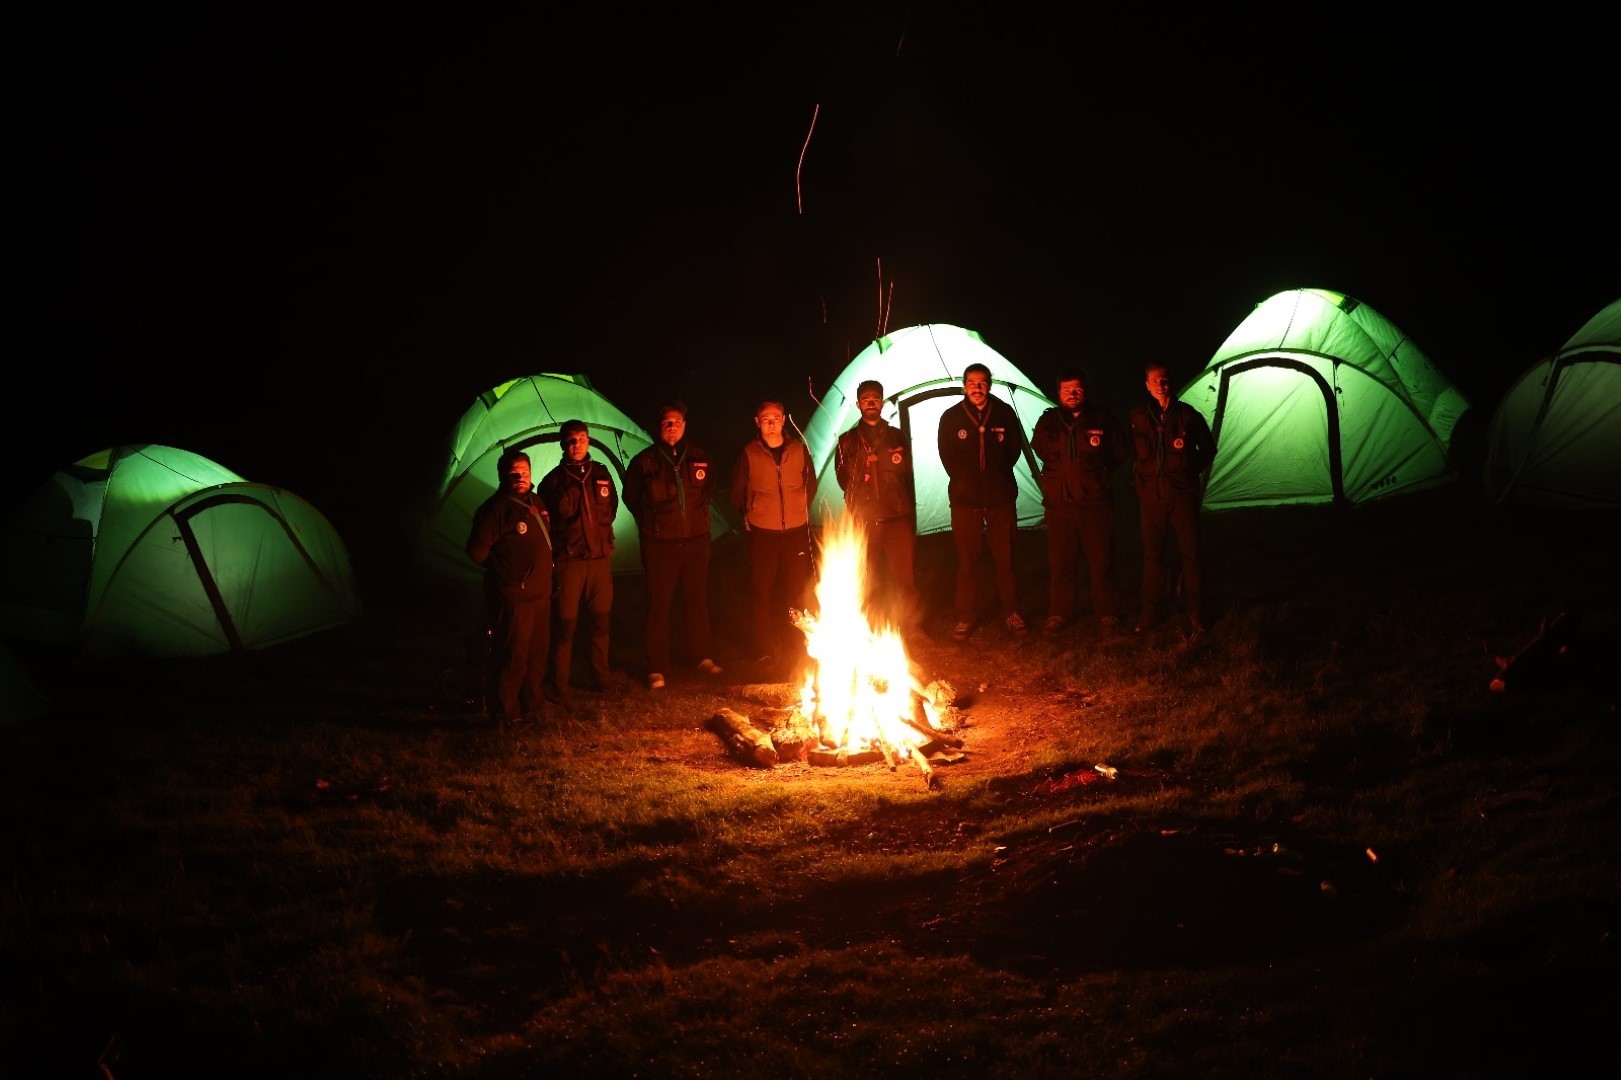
left=712, top=514, right=963, bottom=788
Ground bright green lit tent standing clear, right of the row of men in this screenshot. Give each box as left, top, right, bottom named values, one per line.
left=1178, top=289, right=1469, bottom=509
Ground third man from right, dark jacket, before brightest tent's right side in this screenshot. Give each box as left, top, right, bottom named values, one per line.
left=939, top=363, right=1028, bottom=641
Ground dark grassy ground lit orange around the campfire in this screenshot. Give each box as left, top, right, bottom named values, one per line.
left=0, top=495, right=1621, bottom=1080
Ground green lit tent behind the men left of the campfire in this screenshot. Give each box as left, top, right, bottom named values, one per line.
left=420, top=373, right=725, bottom=582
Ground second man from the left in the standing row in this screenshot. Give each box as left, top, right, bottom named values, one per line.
left=540, top=420, right=619, bottom=701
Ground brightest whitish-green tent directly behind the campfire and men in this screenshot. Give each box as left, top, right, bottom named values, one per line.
left=806, top=323, right=1054, bottom=537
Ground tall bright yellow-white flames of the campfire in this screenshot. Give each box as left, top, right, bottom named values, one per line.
left=794, top=514, right=939, bottom=755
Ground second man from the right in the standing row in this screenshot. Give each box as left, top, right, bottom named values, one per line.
left=1029, top=368, right=1131, bottom=634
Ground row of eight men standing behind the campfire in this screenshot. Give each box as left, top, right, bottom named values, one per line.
left=467, top=363, right=1216, bottom=725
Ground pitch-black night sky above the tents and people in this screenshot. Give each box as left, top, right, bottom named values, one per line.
left=5, top=0, right=1621, bottom=564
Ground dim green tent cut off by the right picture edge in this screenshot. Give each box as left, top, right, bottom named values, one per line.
left=1485, top=300, right=1621, bottom=509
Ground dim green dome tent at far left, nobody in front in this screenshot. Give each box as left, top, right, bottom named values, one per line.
left=0, top=444, right=360, bottom=657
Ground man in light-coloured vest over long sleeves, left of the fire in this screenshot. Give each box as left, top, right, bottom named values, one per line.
left=731, top=399, right=815, bottom=666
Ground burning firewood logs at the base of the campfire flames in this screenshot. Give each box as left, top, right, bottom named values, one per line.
left=705, top=679, right=963, bottom=790
